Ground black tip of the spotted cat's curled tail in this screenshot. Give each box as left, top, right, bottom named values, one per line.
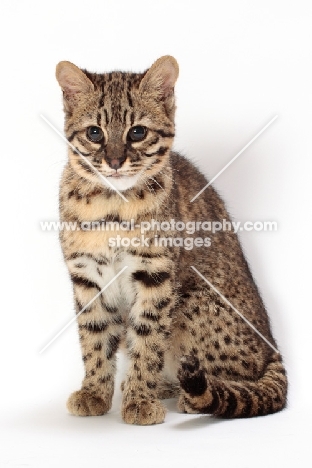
left=178, top=356, right=207, bottom=396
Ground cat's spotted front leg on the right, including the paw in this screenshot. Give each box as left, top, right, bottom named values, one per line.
left=122, top=270, right=174, bottom=425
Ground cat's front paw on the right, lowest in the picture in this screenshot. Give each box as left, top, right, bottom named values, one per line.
left=122, top=400, right=166, bottom=426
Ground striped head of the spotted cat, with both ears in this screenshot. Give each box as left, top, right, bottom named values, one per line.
left=56, top=56, right=178, bottom=191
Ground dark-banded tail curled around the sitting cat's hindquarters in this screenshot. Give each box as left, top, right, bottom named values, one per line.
left=178, top=353, right=287, bottom=418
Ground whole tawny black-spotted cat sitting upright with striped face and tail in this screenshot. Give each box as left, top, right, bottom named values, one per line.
left=56, top=56, right=287, bottom=425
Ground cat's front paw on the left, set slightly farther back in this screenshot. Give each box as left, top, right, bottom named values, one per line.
left=67, top=390, right=111, bottom=416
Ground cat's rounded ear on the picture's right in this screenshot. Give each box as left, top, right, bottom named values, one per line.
left=139, top=55, right=179, bottom=100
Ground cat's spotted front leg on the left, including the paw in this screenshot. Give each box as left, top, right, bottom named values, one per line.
left=67, top=280, right=122, bottom=416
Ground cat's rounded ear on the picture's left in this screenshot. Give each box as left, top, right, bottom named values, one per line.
left=56, top=62, right=94, bottom=109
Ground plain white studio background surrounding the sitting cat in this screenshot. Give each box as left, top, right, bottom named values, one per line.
left=0, top=0, right=312, bottom=468
